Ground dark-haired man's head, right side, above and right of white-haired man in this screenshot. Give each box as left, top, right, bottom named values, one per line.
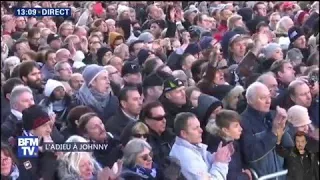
left=270, top=60, right=295, bottom=84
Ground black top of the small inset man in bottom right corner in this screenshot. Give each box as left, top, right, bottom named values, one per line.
left=276, top=145, right=319, bottom=180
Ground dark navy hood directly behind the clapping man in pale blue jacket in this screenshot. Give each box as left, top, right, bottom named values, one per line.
left=195, top=94, right=222, bottom=122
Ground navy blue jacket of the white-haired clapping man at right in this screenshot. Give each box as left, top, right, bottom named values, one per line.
left=240, top=105, right=294, bottom=177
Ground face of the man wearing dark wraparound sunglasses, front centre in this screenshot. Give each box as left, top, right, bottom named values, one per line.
left=146, top=106, right=167, bottom=134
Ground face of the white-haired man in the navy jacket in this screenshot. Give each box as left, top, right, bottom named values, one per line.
left=248, top=87, right=271, bottom=112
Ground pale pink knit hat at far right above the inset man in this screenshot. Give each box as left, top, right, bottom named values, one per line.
left=288, top=105, right=311, bottom=127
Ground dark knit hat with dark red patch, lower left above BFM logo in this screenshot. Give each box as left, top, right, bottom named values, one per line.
left=22, top=105, right=50, bottom=131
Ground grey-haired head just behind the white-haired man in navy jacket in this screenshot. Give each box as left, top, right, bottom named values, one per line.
left=257, top=72, right=279, bottom=98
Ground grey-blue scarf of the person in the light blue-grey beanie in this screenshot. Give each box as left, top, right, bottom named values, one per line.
left=76, top=84, right=110, bottom=113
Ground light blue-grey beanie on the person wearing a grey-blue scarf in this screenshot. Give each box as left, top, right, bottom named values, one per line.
left=82, top=64, right=106, bottom=86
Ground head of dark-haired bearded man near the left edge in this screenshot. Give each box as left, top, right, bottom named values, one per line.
left=19, top=61, right=42, bottom=88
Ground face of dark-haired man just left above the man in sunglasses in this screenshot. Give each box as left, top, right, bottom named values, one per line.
left=121, top=90, right=142, bottom=116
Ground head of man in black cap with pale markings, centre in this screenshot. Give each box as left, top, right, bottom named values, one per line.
left=163, top=77, right=187, bottom=106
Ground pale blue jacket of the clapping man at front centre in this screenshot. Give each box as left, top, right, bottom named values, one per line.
left=169, top=137, right=228, bottom=180
